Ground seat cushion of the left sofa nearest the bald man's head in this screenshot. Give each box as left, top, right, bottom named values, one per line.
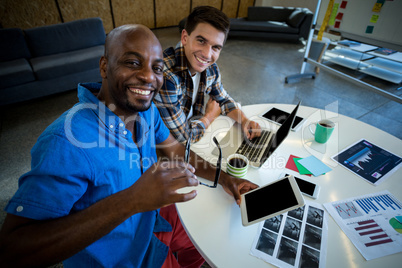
left=31, top=45, right=104, bottom=80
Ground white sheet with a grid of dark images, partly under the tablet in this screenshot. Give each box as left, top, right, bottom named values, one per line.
left=250, top=200, right=328, bottom=267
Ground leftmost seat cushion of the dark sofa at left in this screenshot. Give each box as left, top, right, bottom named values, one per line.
left=0, top=59, right=35, bottom=88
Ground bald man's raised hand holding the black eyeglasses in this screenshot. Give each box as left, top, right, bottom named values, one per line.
left=131, top=161, right=198, bottom=212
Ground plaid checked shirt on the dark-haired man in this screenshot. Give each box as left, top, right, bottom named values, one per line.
left=154, top=43, right=240, bottom=143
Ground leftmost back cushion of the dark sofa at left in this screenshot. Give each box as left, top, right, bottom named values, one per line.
left=0, top=28, right=31, bottom=61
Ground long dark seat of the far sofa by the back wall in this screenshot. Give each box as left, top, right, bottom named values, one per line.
left=229, top=18, right=298, bottom=34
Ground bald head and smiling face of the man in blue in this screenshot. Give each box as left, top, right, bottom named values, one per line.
left=101, top=27, right=163, bottom=114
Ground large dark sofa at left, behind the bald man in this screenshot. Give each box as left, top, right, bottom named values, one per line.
left=0, top=18, right=106, bottom=106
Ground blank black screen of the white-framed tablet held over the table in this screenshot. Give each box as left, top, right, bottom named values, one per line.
left=245, top=180, right=298, bottom=222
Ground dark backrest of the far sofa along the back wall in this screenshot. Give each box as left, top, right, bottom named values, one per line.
left=247, top=7, right=295, bottom=22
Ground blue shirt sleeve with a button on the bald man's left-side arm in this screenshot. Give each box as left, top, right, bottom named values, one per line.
left=6, top=136, right=92, bottom=220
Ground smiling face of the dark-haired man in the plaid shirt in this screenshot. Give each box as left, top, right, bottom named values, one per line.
left=181, top=22, right=225, bottom=75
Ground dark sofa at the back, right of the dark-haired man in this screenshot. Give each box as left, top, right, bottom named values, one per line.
left=229, top=7, right=313, bottom=41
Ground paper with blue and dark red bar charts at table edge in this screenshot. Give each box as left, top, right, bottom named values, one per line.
left=324, top=191, right=402, bottom=260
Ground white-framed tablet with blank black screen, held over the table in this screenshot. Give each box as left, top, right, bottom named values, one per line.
left=240, top=175, right=304, bottom=226
